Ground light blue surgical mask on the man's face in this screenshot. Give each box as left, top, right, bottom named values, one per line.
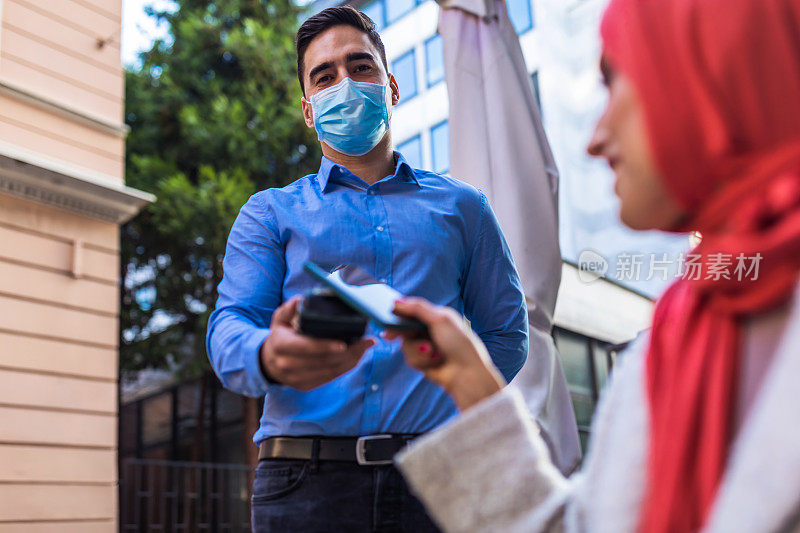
left=311, top=78, right=391, bottom=156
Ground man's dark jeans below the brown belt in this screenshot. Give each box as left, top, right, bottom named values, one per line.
left=252, top=459, right=439, bottom=533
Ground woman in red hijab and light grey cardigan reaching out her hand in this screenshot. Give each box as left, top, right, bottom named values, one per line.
left=382, top=0, right=800, bottom=533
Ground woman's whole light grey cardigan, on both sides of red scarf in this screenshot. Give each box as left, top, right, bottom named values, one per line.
left=396, top=289, right=800, bottom=533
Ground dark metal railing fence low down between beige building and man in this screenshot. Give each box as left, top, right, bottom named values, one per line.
left=119, top=459, right=252, bottom=533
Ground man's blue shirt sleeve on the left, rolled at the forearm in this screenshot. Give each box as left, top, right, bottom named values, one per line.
left=206, top=194, right=286, bottom=397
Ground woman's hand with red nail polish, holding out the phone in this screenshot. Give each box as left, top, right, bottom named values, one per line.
left=383, top=298, right=505, bottom=411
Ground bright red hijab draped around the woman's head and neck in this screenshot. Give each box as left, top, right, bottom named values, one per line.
left=602, top=0, right=800, bottom=533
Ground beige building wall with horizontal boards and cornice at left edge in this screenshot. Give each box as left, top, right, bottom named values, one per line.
left=0, top=0, right=153, bottom=533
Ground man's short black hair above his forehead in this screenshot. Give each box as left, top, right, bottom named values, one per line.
left=295, top=6, right=389, bottom=94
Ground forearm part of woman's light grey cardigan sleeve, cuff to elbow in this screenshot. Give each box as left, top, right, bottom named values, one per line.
left=396, top=388, right=575, bottom=533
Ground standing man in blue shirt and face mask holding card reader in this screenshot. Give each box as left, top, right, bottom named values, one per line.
left=207, top=7, right=528, bottom=533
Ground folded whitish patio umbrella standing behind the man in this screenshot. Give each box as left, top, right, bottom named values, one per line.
left=437, top=0, right=580, bottom=473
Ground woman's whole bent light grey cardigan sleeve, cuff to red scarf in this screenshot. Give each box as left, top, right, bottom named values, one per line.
left=395, top=336, right=647, bottom=533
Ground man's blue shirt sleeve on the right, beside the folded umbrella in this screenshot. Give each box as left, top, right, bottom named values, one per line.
left=462, top=193, right=528, bottom=381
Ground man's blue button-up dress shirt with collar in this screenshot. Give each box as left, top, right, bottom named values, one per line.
left=206, top=153, right=528, bottom=443
